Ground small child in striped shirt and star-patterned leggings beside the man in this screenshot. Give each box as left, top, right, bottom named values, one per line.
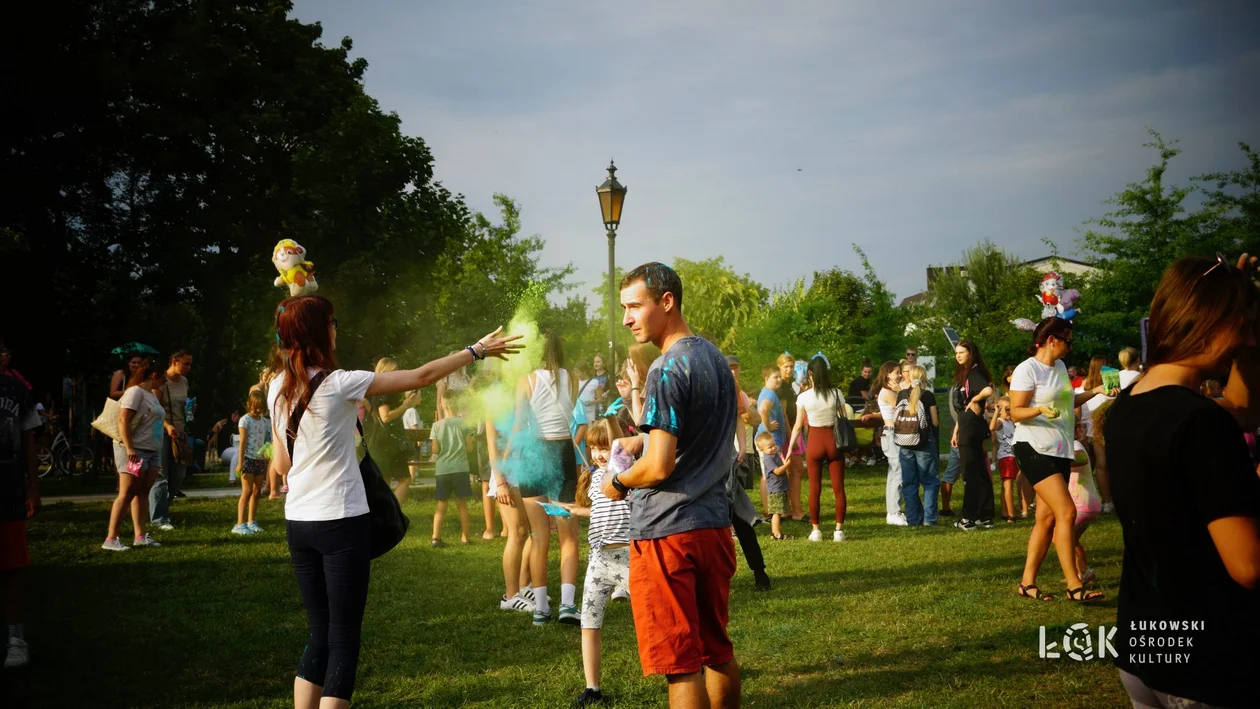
left=564, top=418, right=634, bottom=706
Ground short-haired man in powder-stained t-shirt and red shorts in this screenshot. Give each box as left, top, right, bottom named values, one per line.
left=604, top=263, right=740, bottom=706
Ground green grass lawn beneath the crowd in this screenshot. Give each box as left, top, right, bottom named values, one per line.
left=9, top=468, right=1125, bottom=708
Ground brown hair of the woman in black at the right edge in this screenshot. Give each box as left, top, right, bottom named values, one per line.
left=1145, top=257, right=1260, bottom=369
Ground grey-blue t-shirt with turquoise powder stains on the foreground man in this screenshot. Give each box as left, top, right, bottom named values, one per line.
left=630, top=336, right=738, bottom=540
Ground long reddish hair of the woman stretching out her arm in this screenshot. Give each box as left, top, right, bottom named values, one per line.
left=276, top=296, right=336, bottom=409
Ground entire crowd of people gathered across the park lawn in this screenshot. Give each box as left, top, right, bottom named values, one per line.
left=0, top=258, right=1260, bottom=708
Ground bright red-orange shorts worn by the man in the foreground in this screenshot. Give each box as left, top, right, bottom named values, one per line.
left=630, top=528, right=735, bottom=675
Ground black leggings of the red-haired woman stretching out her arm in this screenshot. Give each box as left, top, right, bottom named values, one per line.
left=285, top=515, right=372, bottom=700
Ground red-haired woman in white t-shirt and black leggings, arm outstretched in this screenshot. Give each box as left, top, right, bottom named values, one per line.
left=267, top=296, right=519, bottom=709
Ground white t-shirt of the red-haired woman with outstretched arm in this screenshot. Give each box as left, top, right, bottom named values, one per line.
left=267, top=369, right=375, bottom=521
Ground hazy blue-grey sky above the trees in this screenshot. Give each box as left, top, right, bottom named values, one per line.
left=295, top=0, right=1260, bottom=296
